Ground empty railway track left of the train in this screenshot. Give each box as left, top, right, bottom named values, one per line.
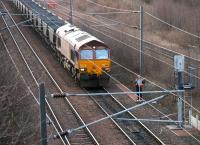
left=1, top=1, right=99, bottom=144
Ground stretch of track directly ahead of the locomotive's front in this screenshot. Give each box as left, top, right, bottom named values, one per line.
left=86, top=89, right=164, bottom=145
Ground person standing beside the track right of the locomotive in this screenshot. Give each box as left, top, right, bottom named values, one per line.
left=135, top=76, right=145, bottom=101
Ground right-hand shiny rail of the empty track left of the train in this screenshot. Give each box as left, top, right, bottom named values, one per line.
left=1, top=2, right=99, bottom=145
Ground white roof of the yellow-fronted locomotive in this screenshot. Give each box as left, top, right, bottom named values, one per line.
left=56, top=23, right=103, bottom=51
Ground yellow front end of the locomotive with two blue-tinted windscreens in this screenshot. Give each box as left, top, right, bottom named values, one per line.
left=78, top=41, right=110, bottom=87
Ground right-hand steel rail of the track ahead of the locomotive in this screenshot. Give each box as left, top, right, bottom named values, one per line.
left=104, top=88, right=165, bottom=145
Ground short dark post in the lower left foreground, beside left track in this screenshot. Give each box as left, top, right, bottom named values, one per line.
left=39, top=83, right=47, bottom=145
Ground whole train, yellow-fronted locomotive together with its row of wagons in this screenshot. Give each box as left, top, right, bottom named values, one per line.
left=13, top=0, right=111, bottom=87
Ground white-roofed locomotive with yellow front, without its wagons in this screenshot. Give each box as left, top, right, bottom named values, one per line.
left=56, top=23, right=110, bottom=87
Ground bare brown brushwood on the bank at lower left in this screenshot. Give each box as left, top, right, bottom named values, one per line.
left=0, top=42, right=39, bottom=145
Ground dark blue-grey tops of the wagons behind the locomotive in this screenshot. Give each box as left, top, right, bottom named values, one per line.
left=21, top=0, right=65, bottom=30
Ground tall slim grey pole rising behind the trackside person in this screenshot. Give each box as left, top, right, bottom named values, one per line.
left=140, top=6, right=144, bottom=76
